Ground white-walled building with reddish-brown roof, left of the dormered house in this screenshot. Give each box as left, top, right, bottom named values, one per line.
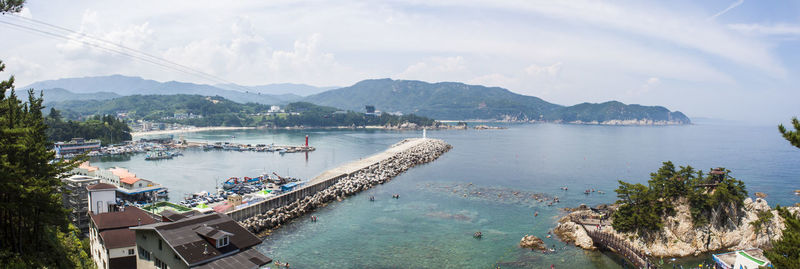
left=89, top=203, right=156, bottom=269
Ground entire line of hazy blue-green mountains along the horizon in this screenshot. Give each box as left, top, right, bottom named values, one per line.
left=23, top=75, right=690, bottom=124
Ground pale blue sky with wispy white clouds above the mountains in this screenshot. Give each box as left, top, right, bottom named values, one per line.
left=0, top=0, right=800, bottom=125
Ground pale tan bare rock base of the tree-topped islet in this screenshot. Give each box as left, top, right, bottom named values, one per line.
left=554, top=198, right=800, bottom=257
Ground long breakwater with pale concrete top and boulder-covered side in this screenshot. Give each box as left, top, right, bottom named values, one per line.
left=227, top=138, right=452, bottom=233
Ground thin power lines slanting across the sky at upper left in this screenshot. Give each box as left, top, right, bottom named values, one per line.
left=0, top=14, right=251, bottom=91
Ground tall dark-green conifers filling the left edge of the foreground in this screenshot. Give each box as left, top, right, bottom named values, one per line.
left=0, top=59, right=94, bottom=268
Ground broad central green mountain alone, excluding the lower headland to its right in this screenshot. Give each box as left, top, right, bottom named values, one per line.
left=303, top=79, right=560, bottom=120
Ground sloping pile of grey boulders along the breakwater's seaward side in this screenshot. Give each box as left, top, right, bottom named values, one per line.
left=239, top=139, right=452, bottom=233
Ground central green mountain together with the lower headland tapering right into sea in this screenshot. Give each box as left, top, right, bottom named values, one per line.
left=304, top=79, right=690, bottom=124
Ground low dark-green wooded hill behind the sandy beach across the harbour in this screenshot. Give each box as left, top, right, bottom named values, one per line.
left=51, top=94, right=437, bottom=127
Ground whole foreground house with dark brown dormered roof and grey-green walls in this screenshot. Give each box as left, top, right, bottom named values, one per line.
left=131, top=213, right=272, bottom=268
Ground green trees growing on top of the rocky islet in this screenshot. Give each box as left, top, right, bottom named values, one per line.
left=613, top=162, right=747, bottom=235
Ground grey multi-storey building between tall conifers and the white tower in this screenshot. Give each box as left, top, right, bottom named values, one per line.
left=61, top=175, right=100, bottom=234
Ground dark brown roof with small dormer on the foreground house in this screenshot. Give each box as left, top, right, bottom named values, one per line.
left=131, top=213, right=269, bottom=268
